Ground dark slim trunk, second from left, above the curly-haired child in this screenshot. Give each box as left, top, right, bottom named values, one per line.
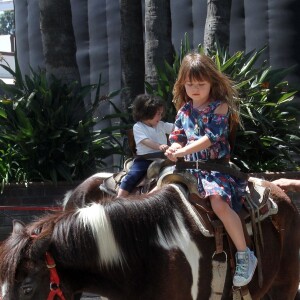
left=120, top=0, right=145, bottom=109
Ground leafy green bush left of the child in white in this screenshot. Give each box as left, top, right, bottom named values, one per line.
left=0, top=62, right=123, bottom=185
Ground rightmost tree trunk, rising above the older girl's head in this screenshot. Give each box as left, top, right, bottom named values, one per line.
left=204, top=0, right=232, bottom=51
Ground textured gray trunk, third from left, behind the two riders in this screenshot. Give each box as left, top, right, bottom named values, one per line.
left=145, top=0, right=174, bottom=87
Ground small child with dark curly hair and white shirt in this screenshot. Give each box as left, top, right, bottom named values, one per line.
left=118, top=94, right=174, bottom=196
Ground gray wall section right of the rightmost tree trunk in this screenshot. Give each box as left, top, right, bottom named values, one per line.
left=230, top=0, right=300, bottom=84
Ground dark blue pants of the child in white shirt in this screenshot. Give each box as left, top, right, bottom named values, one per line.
left=120, top=159, right=153, bottom=193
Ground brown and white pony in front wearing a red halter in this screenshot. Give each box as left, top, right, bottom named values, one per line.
left=0, top=176, right=300, bottom=300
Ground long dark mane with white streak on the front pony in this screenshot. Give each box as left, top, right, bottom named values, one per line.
left=0, top=186, right=189, bottom=284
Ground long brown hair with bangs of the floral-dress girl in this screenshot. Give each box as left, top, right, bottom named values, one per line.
left=173, top=52, right=240, bottom=124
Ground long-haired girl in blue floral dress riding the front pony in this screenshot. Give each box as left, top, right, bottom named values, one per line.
left=165, top=52, right=257, bottom=286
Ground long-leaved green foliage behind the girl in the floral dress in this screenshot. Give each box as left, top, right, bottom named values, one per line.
left=146, top=36, right=300, bottom=172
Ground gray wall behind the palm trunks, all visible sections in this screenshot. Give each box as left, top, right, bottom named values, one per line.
left=14, top=0, right=300, bottom=94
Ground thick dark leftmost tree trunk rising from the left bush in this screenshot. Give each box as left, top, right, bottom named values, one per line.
left=39, top=0, right=80, bottom=82
